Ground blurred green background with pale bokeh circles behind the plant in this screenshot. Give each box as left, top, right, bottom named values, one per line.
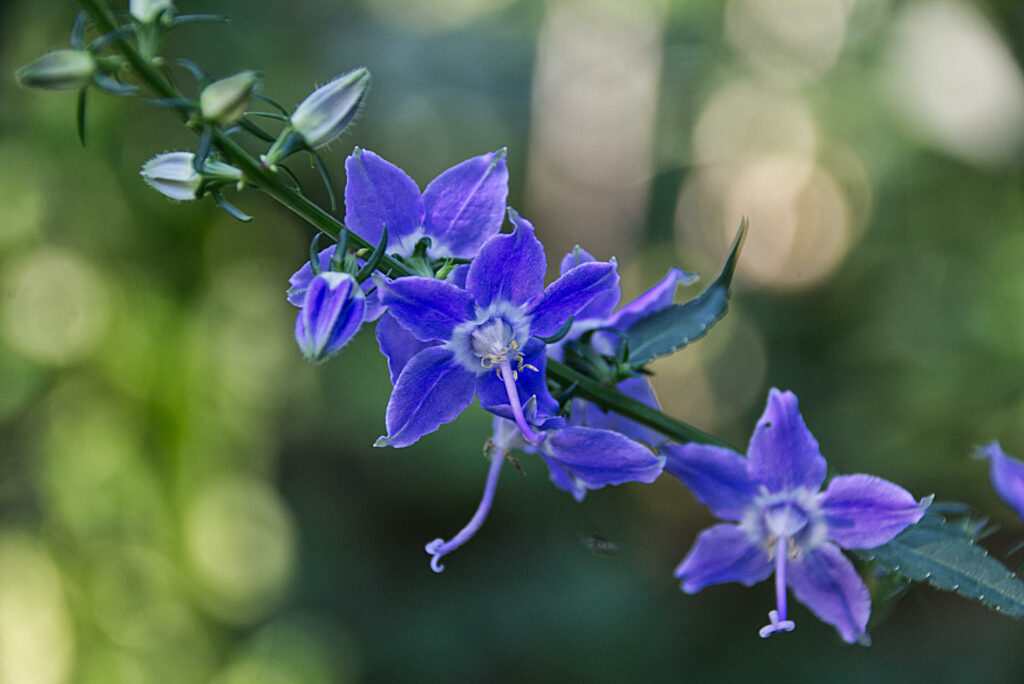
left=0, top=0, right=1024, bottom=684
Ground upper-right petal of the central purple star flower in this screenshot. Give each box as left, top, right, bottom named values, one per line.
left=526, top=261, right=618, bottom=337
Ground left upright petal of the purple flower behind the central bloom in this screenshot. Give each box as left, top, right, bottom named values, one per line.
left=345, top=147, right=423, bottom=250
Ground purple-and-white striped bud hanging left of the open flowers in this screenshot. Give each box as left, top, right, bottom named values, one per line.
left=295, top=271, right=367, bottom=364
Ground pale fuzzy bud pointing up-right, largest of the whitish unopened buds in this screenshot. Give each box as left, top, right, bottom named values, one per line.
left=291, top=69, right=370, bottom=148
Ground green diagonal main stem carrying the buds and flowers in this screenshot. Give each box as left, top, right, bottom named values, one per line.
left=79, top=0, right=730, bottom=446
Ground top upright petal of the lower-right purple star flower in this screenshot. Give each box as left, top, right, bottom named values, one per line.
left=746, top=387, right=827, bottom=491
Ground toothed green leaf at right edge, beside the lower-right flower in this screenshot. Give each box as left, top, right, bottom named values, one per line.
left=853, top=512, right=1024, bottom=617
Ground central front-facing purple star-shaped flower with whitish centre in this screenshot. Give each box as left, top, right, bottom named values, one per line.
left=375, top=212, right=617, bottom=446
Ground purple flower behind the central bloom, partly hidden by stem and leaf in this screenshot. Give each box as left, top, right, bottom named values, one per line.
left=548, top=247, right=697, bottom=447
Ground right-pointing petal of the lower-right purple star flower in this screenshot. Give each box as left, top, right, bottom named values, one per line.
left=818, top=475, right=931, bottom=549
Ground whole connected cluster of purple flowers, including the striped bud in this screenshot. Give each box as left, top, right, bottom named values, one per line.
left=288, top=148, right=930, bottom=642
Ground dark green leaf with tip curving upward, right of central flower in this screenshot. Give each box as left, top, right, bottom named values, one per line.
left=626, top=218, right=746, bottom=370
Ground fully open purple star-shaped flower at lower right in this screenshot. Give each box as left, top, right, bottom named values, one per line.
left=665, top=389, right=931, bottom=643
